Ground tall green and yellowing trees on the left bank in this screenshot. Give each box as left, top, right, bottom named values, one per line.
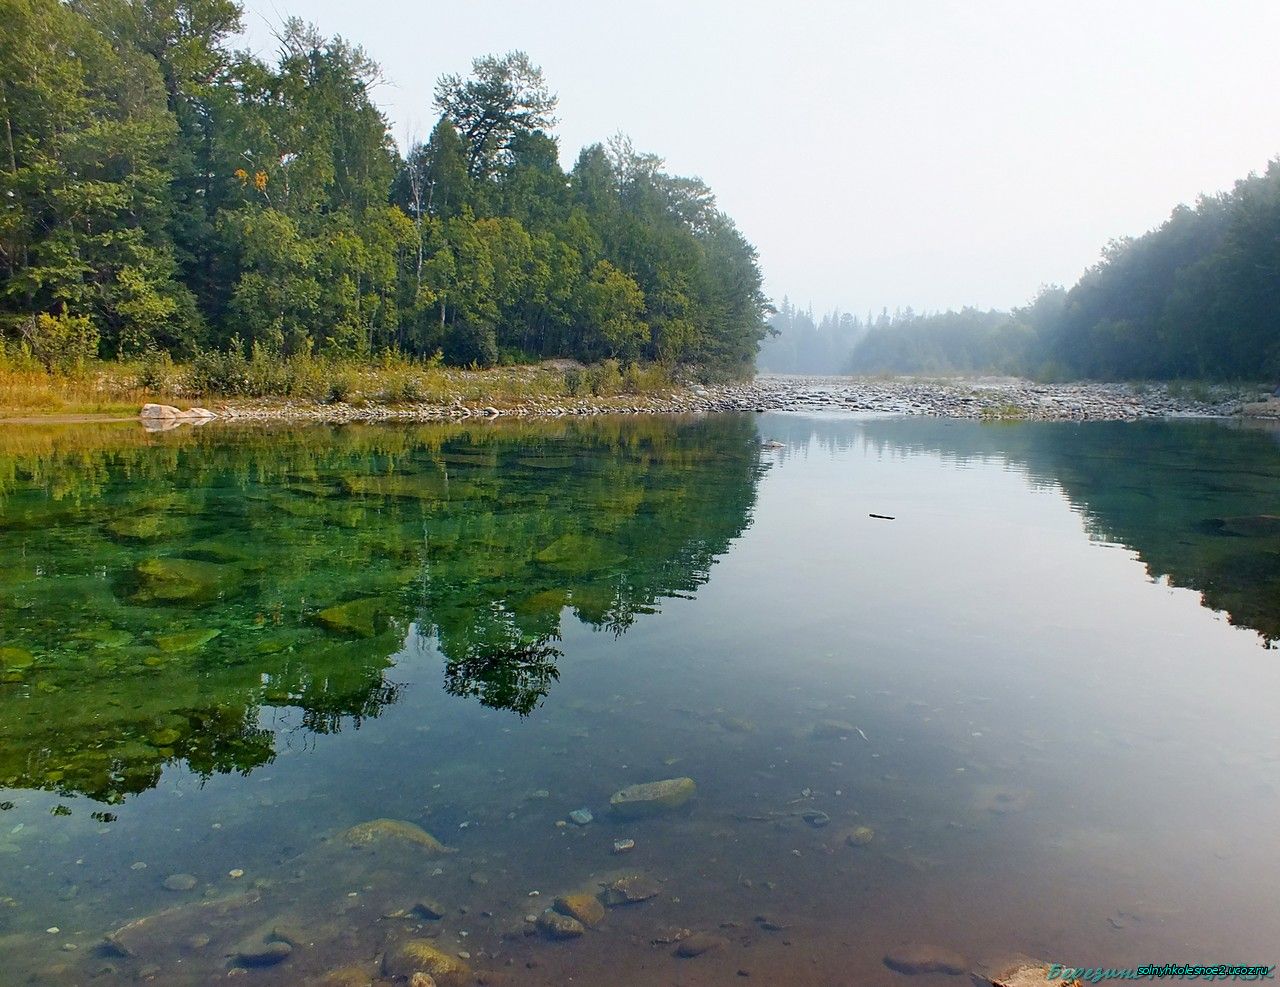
left=0, top=0, right=767, bottom=371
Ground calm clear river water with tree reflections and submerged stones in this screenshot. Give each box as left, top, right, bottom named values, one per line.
left=0, top=415, right=1280, bottom=984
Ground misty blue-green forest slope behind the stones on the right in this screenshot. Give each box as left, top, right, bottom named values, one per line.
left=845, top=159, right=1280, bottom=380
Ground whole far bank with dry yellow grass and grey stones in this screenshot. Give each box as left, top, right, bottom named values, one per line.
left=0, top=364, right=1259, bottom=429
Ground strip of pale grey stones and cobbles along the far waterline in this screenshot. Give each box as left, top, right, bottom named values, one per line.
left=197, top=375, right=1258, bottom=422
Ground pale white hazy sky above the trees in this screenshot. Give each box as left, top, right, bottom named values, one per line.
left=235, top=0, right=1280, bottom=314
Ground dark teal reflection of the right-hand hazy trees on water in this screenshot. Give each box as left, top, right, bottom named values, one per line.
left=776, top=417, right=1280, bottom=648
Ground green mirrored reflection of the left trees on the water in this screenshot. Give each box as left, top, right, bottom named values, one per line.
left=0, top=417, right=760, bottom=804
